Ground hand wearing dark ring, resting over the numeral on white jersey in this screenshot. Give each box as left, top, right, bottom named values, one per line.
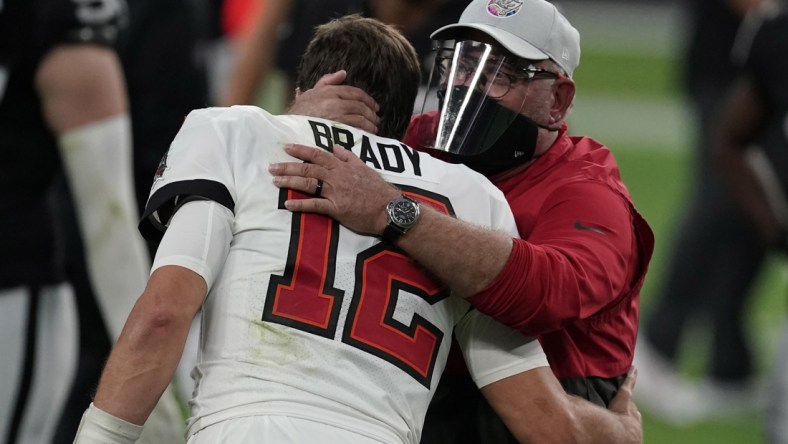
left=268, top=145, right=400, bottom=236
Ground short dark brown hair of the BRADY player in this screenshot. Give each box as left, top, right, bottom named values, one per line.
left=296, top=14, right=421, bottom=139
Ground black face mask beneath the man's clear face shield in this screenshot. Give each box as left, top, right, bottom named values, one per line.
left=438, top=86, right=557, bottom=176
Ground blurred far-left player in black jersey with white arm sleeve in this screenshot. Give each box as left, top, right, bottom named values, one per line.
left=0, top=0, right=179, bottom=443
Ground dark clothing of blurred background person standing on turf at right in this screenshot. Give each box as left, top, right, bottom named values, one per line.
left=644, top=0, right=765, bottom=384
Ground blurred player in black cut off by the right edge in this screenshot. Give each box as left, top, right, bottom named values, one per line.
left=712, top=2, right=788, bottom=438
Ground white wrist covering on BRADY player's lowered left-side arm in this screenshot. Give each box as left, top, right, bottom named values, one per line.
left=74, top=403, right=142, bottom=444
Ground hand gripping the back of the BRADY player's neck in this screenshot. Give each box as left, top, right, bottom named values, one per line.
left=287, top=70, right=380, bottom=134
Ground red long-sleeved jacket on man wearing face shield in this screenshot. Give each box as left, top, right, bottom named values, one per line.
left=406, top=112, right=654, bottom=378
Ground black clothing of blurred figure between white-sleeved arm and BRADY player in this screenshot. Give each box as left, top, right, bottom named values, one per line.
left=118, top=0, right=215, bottom=217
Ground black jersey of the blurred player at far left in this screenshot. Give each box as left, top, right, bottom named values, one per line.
left=0, top=0, right=123, bottom=288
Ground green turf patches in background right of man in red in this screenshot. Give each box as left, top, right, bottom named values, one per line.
left=575, top=40, right=788, bottom=444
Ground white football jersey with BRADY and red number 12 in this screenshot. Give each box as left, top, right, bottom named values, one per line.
left=140, top=106, right=547, bottom=443
